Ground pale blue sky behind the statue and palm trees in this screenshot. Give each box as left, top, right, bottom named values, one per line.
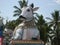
left=0, top=0, right=60, bottom=23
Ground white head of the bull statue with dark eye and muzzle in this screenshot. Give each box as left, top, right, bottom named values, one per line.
left=20, top=3, right=39, bottom=21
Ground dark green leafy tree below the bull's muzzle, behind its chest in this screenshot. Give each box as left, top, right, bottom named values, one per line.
left=5, top=19, right=22, bottom=30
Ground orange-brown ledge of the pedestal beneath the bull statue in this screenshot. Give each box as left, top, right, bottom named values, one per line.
left=12, top=40, right=44, bottom=45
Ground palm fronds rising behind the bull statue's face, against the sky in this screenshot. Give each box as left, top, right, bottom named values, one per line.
left=13, top=0, right=28, bottom=16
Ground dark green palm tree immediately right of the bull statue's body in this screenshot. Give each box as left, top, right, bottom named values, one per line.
left=35, top=14, right=50, bottom=44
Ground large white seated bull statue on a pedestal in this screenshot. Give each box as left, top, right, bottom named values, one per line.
left=12, top=4, right=40, bottom=40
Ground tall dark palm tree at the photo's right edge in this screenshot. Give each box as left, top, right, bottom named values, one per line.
left=47, top=11, right=60, bottom=45
